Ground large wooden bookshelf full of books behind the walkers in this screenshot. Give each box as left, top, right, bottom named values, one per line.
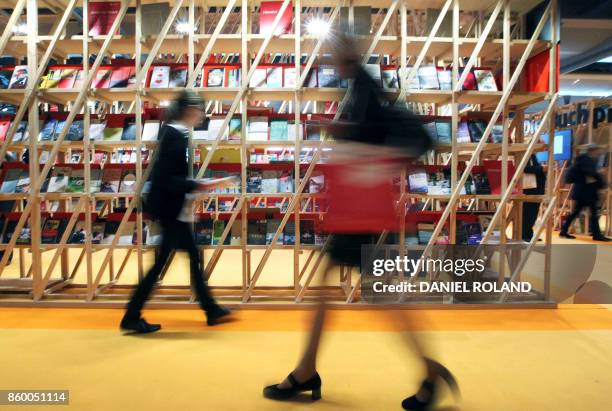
left=0, top=0, right=558, bottom=304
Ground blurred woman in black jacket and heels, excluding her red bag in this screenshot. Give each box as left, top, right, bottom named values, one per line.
left=263, top=37, right=457, bottom=410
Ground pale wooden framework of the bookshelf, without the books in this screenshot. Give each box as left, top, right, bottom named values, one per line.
left=0, top=0, right=559, bottom=305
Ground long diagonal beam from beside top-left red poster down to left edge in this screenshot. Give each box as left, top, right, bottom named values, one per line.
left=0, top=0, right=129, bottom=278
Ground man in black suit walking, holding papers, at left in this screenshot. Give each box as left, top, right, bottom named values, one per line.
left=121, top=91, right=230, bottom=333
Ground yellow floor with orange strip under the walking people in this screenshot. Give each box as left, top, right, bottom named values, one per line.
left=0, top=306, right=612, bottom=411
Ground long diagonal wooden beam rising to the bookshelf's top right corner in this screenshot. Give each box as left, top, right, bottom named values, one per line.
left=423, top=3, right=551, bottom=257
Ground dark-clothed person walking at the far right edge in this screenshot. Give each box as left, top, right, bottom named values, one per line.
left=559, top=144, right=610, bottom=241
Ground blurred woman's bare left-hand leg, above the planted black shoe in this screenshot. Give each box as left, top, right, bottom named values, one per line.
left=279, top=263, right=335, bottom=388
